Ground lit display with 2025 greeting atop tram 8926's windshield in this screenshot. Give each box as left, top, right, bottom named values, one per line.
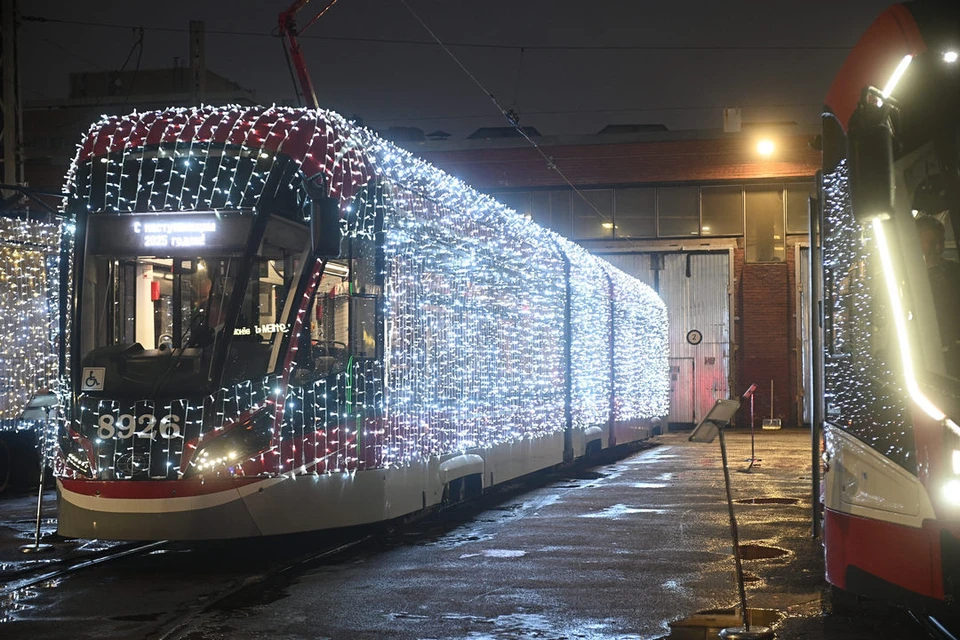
left=87, top=211, right=253, bottom=257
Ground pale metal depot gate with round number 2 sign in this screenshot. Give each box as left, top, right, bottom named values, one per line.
left=603, top=252, right=730, bottom=423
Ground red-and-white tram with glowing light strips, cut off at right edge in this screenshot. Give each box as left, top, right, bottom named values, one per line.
left=814, top=1, right=960, bottom=609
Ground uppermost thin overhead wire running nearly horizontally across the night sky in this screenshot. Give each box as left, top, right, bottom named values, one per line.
left=21, top=16, right=853, bottom=51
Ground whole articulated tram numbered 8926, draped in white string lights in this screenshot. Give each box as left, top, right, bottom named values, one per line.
left=56, top=106, right=669, bottom=540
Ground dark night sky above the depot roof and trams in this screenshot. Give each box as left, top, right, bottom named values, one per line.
left=19, top=0, right=890, bottom=137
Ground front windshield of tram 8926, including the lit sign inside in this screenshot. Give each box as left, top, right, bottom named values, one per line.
left=78, top=213, right=309, bottom=397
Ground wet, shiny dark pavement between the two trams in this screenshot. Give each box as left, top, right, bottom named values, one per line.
left=0, top=429, right=926, bottom=640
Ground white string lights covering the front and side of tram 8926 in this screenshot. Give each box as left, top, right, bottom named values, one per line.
left=59, top=106, right=669, bottom=479
